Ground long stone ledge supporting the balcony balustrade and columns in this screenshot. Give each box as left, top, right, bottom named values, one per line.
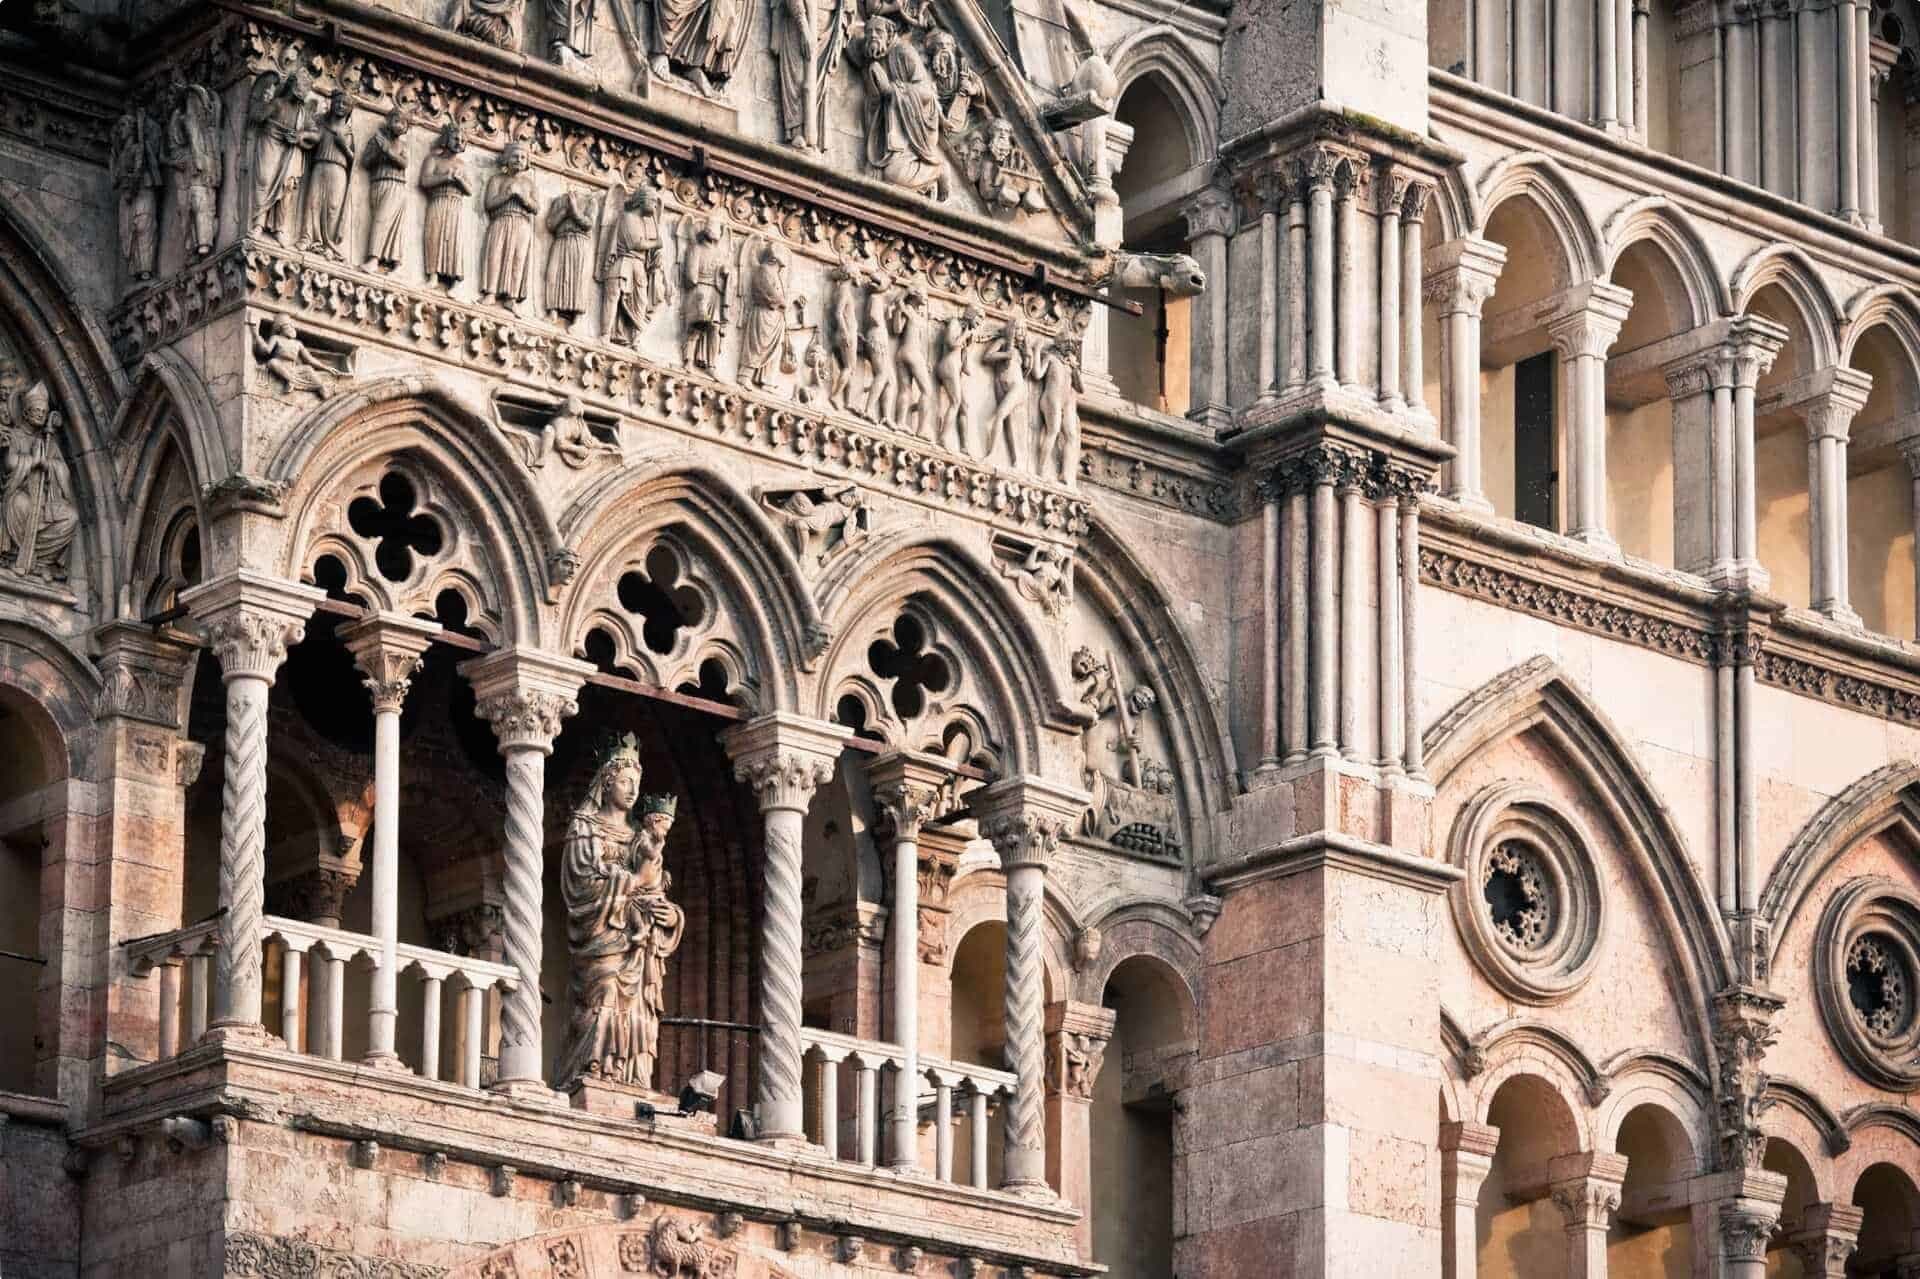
left=90, top=1045, right=1098, bottom=1277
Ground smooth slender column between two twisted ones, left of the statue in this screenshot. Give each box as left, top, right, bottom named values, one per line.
left=340, top=613, right=440, bottom=1068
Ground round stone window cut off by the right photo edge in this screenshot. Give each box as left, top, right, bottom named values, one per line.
left=1814, top=876, right=1920, bottom=1093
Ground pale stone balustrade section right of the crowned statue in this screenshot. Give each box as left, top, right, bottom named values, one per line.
left=801, top=1029, right=1020, bottom=1191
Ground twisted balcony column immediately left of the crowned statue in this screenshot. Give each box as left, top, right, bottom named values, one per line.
left=459, top=647, right=593, bottom=1100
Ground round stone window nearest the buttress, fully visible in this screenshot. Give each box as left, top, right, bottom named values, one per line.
left=1450, top=782, right=1605, bottom=1004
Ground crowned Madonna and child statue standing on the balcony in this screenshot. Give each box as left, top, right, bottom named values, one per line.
left=555, top=734, right=685, bottom=1114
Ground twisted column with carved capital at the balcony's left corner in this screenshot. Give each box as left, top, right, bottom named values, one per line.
left=180, top=568, right=326, bottom=1039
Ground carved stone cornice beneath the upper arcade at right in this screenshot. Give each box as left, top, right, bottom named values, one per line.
left=1421, top=503, right=1920, bottom=724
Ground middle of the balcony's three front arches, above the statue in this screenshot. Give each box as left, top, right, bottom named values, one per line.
left=555, top=465, right=826, bottom=712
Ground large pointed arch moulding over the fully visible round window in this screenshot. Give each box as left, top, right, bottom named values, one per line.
left=1425, top=657, right=1734, bottom=1062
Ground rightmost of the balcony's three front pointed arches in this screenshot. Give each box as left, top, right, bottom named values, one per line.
left=814, top=530, right=1085, bottom=776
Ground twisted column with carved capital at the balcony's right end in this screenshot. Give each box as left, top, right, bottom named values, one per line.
left=968, top=778, right=1089, bottom=1196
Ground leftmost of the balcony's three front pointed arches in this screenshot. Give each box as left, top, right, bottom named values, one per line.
left=265, top=376, right=568, bottom=645
